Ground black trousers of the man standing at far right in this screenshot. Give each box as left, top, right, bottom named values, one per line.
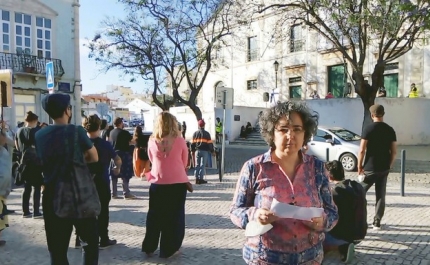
left=361, top=170, right=390, bottom=221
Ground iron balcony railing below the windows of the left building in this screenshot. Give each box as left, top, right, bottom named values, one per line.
left=0, top=52, right=64, bottom=77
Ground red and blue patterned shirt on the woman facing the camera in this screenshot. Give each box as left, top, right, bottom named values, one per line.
left=230, top=150, right=338, bottom=264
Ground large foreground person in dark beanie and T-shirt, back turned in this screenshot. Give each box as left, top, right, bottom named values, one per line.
left=35, top=94, right=99, bottom=265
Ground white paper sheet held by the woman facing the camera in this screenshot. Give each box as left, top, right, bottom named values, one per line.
left=270, top=199, right=324, bottom=221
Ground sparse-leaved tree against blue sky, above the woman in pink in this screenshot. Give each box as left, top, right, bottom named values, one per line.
left=88, top=0, right=234, bottom=119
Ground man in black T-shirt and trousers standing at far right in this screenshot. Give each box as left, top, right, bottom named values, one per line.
left=358, top=104, right=397, bottom=229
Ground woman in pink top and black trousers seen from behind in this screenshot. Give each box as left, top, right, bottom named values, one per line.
left=142, top=111, right=189, bottom=258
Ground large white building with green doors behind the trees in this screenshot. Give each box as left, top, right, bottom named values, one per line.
left=199, top=5, right=430, bottom=139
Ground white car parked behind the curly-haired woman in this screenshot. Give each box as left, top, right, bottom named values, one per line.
left=307, top=127, right=361, bottom=171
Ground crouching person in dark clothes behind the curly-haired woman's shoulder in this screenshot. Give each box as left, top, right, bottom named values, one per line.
left=324, top=160, right=367, bottom=263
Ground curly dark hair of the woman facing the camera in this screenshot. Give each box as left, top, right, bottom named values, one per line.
left=259, top=101, right=319, bottom=149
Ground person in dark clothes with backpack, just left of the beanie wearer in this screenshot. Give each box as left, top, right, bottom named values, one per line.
left=15, top=111, right=43, bottom=219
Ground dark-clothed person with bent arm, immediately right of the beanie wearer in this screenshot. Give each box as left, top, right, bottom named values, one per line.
left=80, top=115, right=122, bottom=249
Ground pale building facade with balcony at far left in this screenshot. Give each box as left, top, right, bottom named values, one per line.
left=0, top=0, right=82, bottom=128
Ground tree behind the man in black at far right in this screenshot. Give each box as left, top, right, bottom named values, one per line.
left=251, top=0, right=430, bottom=130
